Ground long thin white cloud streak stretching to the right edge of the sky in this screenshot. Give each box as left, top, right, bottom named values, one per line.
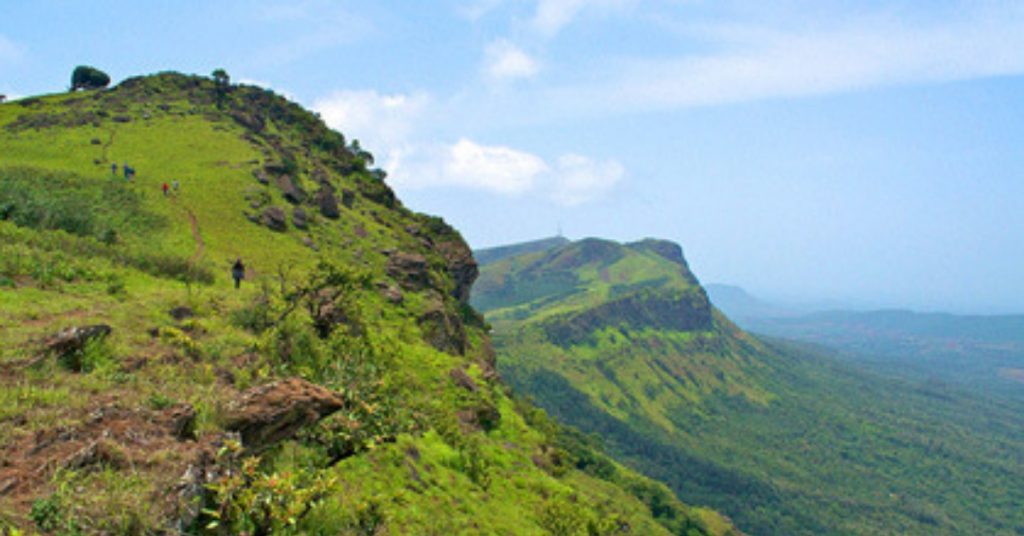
left=549, top=9, right=1024, bottom=112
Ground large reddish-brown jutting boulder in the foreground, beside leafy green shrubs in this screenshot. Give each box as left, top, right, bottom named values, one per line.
left=224, top=378, right=344, bottom=452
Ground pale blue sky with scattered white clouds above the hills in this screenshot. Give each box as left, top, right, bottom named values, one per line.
left=0, top=0, right=1024, bottom=313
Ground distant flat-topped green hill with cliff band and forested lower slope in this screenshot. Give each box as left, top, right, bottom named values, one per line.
left=473, top=239, right=1024, bottom=535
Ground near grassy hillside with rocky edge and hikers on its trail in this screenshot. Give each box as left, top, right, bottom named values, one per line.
left=0, top=73, right=734, bottom=534
